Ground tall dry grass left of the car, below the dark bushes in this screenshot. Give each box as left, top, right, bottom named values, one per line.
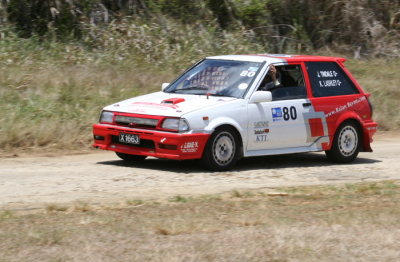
left=0, top=22, right=266, bottom=152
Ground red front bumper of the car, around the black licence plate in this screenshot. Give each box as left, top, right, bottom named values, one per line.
left=93, top=124, right=210, bottom=160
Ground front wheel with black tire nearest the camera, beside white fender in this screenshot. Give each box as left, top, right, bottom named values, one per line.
left=202, top=127, right=241, bottom=171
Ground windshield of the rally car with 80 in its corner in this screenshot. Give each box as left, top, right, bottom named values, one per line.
left=165, top=59, right=261, bottom=98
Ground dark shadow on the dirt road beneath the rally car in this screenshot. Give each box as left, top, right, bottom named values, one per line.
left=97, top=153, right=381, bottom=173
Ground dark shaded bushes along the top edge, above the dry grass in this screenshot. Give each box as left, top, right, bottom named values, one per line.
left=1, top=0, right=400, bottom=56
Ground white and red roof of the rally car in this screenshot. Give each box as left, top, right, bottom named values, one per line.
left=207, top=54, right=346, bottom=63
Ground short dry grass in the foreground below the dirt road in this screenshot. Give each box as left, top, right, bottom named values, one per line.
left=0, top=181, right=400, bottom=261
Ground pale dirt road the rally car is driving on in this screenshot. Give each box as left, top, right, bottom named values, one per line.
left=0, top=134, right=400, bottom=209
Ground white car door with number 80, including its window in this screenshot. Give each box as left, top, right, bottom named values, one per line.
left=247, top=64, right=312, bottom=151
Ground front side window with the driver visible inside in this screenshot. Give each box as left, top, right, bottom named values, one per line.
left=258, top=65, right=307, bottom=101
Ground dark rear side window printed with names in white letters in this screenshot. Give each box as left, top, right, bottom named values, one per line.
left=306, top=62, right=359, bottom=97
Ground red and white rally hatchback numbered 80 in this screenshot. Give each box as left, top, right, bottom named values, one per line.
left=93, top=54, right=377, bottom=170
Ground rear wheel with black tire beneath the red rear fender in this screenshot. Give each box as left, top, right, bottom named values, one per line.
left=325, top=121, right=361, bottom=163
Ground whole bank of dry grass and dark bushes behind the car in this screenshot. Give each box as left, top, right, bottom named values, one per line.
left=0, top=0, right=400, bottom=152
